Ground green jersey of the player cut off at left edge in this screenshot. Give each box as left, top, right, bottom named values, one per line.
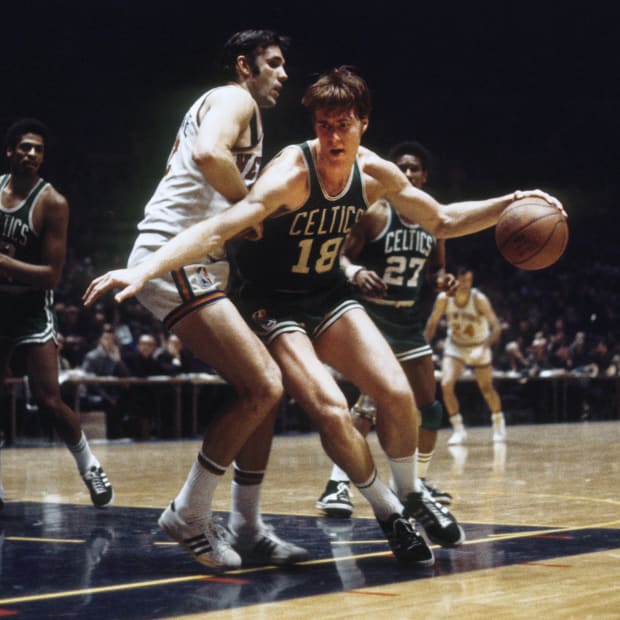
left=0, top=174, right=47, bottom=294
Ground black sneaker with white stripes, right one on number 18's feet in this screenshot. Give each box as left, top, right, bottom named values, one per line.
left=403, top=491, right=465, bottom=547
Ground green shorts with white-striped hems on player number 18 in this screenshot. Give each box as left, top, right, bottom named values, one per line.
left=230, top=281, right=363, bottom=344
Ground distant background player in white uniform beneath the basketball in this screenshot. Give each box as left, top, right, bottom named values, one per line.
left=425, top=267, right=506, bottom=445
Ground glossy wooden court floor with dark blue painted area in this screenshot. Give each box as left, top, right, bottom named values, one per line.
left=0, top=421, right=620, bottom=620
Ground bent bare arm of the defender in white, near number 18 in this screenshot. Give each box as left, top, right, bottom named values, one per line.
left=192, top=85, right=258, bottom=204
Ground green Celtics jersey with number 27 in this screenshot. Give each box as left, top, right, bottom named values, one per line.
left=355, top=204, right=437, bottom=305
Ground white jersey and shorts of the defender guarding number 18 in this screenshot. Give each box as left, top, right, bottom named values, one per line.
left=128, top=83, right=263, bottom=329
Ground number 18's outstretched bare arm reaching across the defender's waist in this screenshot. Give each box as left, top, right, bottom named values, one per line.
left=82, top=148, right=309, bottom=306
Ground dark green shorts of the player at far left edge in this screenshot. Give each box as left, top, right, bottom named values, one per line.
left=0, top=291, right=58, bottom=346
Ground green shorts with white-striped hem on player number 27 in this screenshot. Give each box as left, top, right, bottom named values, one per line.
left=362, top=300, right=433, bottom=362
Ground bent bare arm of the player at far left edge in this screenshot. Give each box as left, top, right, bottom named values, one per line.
left=0, top=187, right=69, bottom=289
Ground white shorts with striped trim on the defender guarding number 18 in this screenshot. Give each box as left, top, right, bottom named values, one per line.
left=127, top=232, right=230, bottom=329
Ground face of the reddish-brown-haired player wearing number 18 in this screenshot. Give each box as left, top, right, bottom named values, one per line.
left=314, top=108, right=368, bottom=163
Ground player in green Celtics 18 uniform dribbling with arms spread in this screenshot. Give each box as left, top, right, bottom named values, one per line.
left=83, top=67, right=562, bottom=565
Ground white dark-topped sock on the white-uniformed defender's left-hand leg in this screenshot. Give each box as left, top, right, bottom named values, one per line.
left=174, top=452, right=226, bottom=523
